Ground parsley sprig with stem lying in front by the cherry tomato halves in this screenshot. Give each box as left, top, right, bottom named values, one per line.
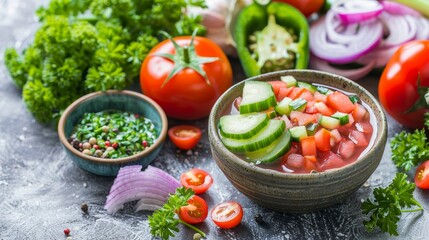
left=149, top=187, right=206, bottom=240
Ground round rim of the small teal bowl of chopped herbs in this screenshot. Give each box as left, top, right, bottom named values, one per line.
left=58, top=90, right=168, bottom=165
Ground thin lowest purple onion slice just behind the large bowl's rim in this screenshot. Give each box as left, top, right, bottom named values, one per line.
left=310, top=56, right=375, bottom=81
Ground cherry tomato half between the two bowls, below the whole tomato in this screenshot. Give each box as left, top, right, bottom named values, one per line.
left=168, top=125, right=201, bottom=150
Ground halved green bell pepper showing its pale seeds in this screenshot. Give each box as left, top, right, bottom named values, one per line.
left=234, top=2, right=309, bottom=77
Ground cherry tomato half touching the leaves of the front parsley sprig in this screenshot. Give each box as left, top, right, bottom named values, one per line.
left=179, top=195, right=209, bottom=224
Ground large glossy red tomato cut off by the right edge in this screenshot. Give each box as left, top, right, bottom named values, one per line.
left=378, top=40, right=429, bottom=128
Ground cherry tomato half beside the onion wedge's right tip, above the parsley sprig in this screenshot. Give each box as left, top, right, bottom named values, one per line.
left=180, top=168, right=213, bottom=194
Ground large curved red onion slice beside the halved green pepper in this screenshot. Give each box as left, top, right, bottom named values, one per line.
left=310, top=17, right=383, bottom=64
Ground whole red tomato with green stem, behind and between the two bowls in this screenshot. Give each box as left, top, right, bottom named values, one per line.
left=140, top=32, right=232, bottom=120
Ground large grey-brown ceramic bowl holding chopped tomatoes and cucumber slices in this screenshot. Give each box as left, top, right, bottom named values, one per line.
left=208, top=70, right=387, bottom=213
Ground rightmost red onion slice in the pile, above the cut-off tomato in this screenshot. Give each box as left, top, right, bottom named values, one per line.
left=380, top=12, right=417, bottom=48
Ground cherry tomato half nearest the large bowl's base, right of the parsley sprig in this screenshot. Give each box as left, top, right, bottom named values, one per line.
left=210, top=201, right=243, bottom=228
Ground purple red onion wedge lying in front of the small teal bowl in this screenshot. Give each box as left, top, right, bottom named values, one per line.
left=104, top=166, right=180, bottom=214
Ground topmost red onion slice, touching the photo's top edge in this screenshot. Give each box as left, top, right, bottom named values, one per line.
left=332, top=0, right=383, bottom=24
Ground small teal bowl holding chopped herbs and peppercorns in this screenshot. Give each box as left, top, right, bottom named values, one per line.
left=58, top=90, right=168, bottom=176
